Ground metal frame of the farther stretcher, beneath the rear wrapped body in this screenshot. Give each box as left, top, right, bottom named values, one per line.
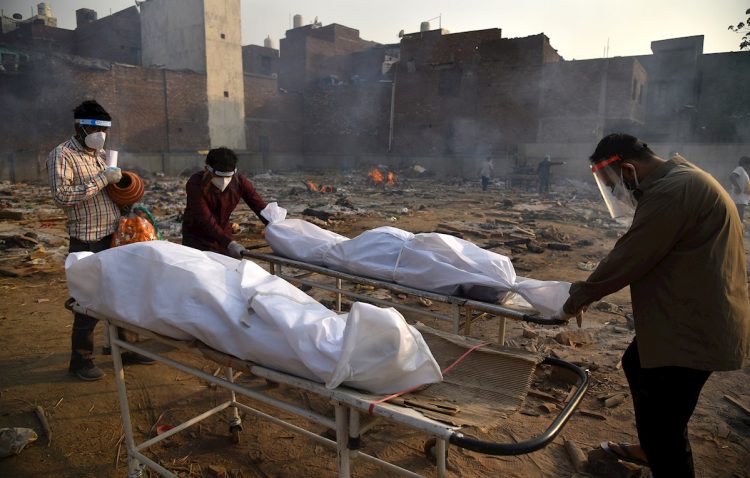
left=243, top=243, right=567, bottom=345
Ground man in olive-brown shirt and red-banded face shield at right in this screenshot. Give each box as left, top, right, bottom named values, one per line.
left=559, top=134, right=750, bottom=478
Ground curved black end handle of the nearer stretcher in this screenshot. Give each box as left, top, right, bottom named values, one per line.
left=448, top=357, right=589, bottom=455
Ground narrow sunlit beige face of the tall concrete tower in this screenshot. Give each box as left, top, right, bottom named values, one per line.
left=203, top=0, right=246, bottom=149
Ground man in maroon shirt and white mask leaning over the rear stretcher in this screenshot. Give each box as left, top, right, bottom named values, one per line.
left=182, top=148, right=268, bottom=259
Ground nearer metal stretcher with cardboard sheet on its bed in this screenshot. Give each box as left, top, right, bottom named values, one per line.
left=67, top=265, right=588, bottom=478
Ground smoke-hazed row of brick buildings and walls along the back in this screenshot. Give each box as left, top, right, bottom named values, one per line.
left=0, top=0, right=750, bottom=177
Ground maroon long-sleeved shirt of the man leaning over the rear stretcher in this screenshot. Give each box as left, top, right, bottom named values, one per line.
left=182, top=171, right=268, bottom=254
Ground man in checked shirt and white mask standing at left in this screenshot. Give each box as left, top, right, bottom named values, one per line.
left=47, top=100, right=154, bottom=381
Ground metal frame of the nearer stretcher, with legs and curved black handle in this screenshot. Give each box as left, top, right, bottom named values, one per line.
left=66, top=299, right=589, bottom=478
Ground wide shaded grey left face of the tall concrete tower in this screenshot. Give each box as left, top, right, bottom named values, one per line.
left=141, top=0, right=206, bottom=73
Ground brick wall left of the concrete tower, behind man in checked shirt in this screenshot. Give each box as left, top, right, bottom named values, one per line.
left=0, top=55, right=208, bottom=152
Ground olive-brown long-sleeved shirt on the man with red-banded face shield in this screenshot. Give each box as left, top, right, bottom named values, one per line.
left=564, top=158, right=750, bottom=370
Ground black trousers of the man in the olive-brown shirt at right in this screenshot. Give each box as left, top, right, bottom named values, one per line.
left=622, top=339, right=711, bottom=478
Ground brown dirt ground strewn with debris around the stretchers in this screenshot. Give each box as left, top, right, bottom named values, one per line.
left=0, top=172, right=750, bottom=477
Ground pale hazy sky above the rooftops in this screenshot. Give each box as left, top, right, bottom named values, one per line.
left=0, top=0, right=750, bottom=60
